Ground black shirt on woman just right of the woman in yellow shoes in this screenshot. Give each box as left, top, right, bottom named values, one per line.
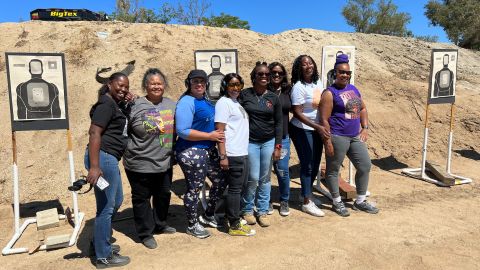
left=238, top=87, right=282, bottom=144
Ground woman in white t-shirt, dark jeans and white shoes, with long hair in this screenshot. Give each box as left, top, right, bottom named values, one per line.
left=289, top=55, right=329, bottom=217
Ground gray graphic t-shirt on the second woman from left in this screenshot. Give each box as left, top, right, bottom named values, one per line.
left=123, top=97, right=175, bottom=173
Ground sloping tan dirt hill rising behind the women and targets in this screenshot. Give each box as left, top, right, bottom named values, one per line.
left=0, top=22, right=480, bottom=202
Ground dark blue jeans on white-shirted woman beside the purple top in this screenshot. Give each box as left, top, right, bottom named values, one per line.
left=289, top=124, right=323, bottom=198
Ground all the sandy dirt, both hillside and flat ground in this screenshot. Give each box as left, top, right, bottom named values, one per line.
left=0, top=22, right=480, bottom=269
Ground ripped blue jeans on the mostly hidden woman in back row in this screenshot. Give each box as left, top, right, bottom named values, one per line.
left=273, top=135, right=290, bottom=202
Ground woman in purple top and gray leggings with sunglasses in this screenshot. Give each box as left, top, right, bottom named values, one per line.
left=320, top=54, right=379, bottom=217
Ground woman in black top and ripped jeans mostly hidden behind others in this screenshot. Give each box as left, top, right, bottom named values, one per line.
left=268, top=62, right=292, bottom=216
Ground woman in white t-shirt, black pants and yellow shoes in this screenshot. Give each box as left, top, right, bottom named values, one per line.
left=215, top=73, right=255, bottom=236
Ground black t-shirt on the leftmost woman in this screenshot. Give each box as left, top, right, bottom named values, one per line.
left=90, top=95, right=128, bottom=160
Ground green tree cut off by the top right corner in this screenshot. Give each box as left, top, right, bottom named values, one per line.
left=425, top=0, right=480, bottom=50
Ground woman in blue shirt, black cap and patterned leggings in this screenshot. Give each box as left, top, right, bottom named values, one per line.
left=175, top=69, right=225, bottom=238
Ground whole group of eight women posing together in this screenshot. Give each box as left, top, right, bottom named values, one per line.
left=85, top=54, right=378, bottom=268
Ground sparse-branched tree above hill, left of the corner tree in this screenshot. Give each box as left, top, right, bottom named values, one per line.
left=342, top=0, right=413, bottom=36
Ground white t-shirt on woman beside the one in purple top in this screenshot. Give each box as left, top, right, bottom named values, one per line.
left=290, top=80, right=325, bottom=130
